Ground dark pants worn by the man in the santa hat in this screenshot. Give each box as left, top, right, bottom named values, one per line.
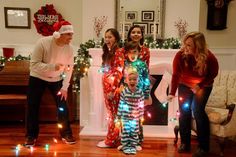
left=26, top=76, right=72, bottom=138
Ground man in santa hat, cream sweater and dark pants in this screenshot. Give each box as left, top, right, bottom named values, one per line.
left=25, top=21, right=75, bottom=147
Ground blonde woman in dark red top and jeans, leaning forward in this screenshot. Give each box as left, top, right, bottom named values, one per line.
left=168, top=32, right=219, bottom=157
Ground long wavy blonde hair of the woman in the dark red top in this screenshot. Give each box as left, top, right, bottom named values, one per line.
left=183, top=32, right=208, bottom=75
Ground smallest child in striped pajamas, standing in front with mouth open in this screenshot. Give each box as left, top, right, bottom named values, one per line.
left=117, top=66, right=144, bottom=154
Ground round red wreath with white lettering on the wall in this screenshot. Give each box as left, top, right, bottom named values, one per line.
left=34, top=4, right=63, bottom=36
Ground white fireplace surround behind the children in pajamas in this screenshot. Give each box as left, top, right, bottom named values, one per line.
left=80, top=49, right=178, bottom=137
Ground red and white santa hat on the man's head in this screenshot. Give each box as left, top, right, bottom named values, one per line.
left=53, top=21, right=74, bottom=39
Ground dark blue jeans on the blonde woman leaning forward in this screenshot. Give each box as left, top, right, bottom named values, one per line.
left=178, top=84, right=212, bottom=151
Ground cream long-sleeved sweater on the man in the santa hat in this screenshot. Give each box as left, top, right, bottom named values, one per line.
left=30, top=36, right=74, bottom=90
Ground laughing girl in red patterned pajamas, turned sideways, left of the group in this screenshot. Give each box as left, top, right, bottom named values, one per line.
left=97, top=28, right=124, bottom=147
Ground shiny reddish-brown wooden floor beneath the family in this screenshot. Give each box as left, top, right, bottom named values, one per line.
left=0, top=123, right=236, bottom=157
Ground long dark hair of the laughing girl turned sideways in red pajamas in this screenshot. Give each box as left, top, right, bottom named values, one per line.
left=102, top=28, right=120, bottom=65
